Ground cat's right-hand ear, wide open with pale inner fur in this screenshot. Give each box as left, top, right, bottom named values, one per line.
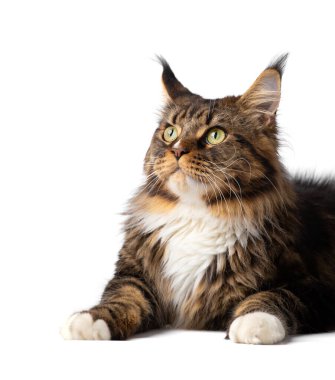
left=239, top=54, right=288, bottom=116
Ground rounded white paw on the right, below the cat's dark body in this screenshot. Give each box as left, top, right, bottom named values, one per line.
left=229, top=311, right=285, bottom=344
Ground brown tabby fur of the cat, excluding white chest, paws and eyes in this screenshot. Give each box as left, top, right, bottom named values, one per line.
left=71, top=56, right=335, bottom=339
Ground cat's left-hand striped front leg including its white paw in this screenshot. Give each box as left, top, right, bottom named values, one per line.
left=61, top=276, right=160, bottom=340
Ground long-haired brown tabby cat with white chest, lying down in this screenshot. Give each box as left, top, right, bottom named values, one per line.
left=62, top=54, right=335, bottom=344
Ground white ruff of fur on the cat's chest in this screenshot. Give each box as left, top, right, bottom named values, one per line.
left=143, top=202, right=256, bottom=314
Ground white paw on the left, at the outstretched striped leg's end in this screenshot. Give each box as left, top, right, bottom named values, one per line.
left=60, top=313, right=111, bottom=340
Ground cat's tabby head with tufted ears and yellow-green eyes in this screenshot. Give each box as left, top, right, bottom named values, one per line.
left=145, top=55, right=287, bottom=212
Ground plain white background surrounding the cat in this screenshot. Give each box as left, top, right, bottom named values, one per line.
left=0, top=0, right=335, bottom=379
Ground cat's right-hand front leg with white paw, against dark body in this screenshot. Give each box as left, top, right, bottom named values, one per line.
left=228, top=280, right=335, bottom=344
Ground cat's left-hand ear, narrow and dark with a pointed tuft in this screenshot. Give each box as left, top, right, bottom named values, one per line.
left=157, top=56, right=196, bottom=104
